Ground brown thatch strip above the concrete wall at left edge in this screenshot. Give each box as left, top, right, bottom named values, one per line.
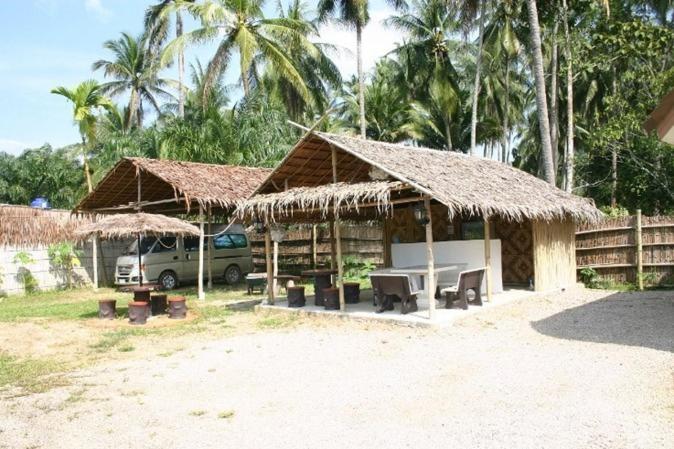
left=0, top=204, right=95, bottom=248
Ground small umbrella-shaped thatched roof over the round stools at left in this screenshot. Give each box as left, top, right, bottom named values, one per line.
left=75, top=213, right=199, bottom=239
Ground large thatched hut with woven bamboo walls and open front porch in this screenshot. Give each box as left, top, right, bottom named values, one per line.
left=239, top=132, right=601, bottom=315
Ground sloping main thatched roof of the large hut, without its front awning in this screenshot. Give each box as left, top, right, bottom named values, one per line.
left=244, top=132, right=602, bottom=222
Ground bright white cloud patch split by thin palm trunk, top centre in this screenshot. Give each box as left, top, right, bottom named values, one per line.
left=319, top=9, right=403, bottom=77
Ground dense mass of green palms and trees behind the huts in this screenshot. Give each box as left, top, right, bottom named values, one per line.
left=0, top=0, right=674, bottom=214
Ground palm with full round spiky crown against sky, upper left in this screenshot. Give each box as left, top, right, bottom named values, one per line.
left=93, top=33, right=175, bottom=127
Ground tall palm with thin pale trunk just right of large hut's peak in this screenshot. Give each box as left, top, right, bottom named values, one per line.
left=318, top=0, right=407, bottom=138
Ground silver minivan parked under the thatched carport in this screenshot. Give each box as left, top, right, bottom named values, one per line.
left=115, top=225, right=253, bottom=289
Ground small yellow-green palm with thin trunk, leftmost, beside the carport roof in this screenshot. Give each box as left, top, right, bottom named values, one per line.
left=51, top=80, right=114, bottom=192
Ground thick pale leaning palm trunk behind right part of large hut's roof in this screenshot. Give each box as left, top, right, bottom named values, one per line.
left=527, top=0, right=555, bottom=186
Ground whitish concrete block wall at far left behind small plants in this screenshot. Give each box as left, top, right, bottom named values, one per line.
left=0, top=240, right=130, bottom=295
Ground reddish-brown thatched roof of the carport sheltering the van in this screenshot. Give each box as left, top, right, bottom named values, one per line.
left=75, top=157, right=271, bottom=213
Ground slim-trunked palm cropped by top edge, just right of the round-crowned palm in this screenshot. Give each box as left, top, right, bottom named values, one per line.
left=145, top=0, right=194, bottom=117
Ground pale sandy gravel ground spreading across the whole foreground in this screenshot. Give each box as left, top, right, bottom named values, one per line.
left=0, top=290, right=674, bottom=449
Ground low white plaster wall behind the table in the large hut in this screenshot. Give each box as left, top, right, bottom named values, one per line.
left=391, top=240, right=503, bottom=293
